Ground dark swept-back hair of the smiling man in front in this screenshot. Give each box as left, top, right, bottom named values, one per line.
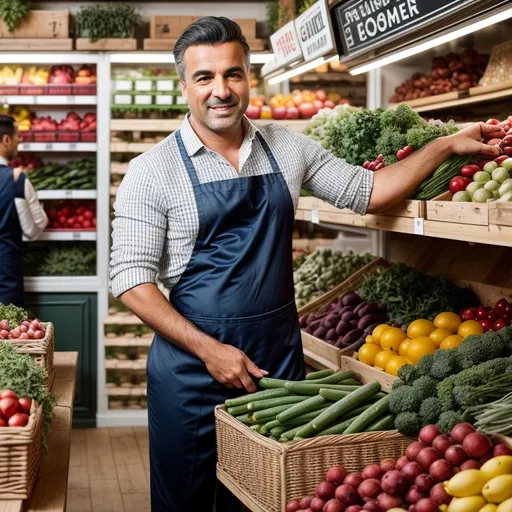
left=173, top=16, right=250, bottom=80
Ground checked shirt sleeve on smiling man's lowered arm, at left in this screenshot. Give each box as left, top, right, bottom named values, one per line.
left=110, top=157, right=167, bottom=297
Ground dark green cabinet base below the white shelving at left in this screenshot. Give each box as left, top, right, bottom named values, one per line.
left=25, top=293, right=98, bottom=427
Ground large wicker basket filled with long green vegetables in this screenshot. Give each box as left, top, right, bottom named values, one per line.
left=215, top=406, right=414, bottom=512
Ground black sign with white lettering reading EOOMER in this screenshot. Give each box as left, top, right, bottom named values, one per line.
left=331, top=0, right=478, bottom=56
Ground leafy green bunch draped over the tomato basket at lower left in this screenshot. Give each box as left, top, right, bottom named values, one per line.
left=0, top=342, right=56, bottom=453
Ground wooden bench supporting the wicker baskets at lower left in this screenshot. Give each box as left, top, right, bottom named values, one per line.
left=0, top=352, right=78, bottom=512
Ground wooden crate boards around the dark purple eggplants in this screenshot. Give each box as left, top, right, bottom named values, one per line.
left=298, top=258, right=391, bottom=369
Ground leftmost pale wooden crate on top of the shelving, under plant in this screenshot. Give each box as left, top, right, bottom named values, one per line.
left=0, top=9, right=69, bottom=39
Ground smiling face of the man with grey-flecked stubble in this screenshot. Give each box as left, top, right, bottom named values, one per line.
left=181, top=42, right=249, bottom=132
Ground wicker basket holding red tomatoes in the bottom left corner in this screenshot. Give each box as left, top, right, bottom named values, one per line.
left=0, top=402, right=43, bottom=500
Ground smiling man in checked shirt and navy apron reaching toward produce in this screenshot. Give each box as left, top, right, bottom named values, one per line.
left=111, top=17, right=500, bottom=512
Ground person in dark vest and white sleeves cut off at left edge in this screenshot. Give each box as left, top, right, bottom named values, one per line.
left=0, top=115, right=48, bottom=306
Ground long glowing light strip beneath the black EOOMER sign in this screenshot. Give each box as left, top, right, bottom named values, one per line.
left=349, top=9, right=512, bottom=76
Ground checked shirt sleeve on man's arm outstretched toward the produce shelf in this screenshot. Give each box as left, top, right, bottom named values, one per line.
left=300, top=135, right=373, bottom=214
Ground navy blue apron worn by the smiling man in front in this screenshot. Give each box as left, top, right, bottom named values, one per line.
left=147, top=131, right=304, bottom=512
